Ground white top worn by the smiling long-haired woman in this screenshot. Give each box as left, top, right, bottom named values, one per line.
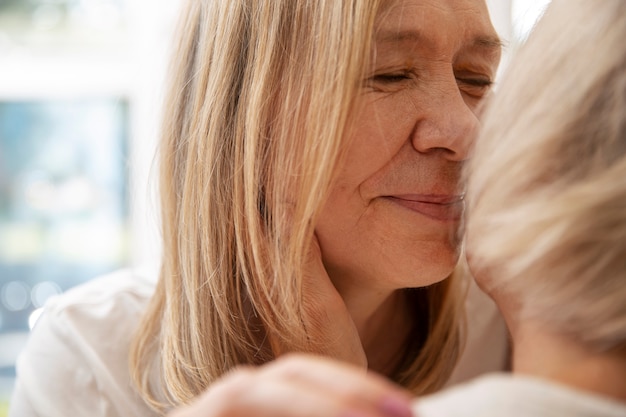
left=9, top=270, right=508, bottom=417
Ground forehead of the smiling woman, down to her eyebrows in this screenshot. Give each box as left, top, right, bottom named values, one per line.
left=376, top=0, right=501, bottom=53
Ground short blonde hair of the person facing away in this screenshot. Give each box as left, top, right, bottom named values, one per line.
left=467, top=0, right=626, bottom=351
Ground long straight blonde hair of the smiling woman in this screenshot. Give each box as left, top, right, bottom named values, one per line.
left=131, top=0, right=460, bottom=410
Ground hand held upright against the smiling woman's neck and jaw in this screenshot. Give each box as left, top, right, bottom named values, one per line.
left=272, top=237, right=367, bottom=369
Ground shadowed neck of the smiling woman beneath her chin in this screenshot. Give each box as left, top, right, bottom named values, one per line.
left=337, top=278, right=412, bottom=376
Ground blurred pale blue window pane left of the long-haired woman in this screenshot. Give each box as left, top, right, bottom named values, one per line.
left=0, top=98, right=128, bottom=304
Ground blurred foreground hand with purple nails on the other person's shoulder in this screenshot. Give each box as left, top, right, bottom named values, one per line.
left=169, top=354, right=412, bottom=417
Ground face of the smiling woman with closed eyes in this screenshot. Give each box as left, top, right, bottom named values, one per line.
left=316, top=0, right=500, bottom=290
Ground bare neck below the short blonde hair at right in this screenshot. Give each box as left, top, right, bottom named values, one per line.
left=512, top=323, right=626, bottom=402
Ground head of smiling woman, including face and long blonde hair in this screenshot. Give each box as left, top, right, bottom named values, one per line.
left=135, top=0, right=500, bottom=410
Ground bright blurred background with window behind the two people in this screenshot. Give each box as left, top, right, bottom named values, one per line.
left=0, top=0, right=549, bottom=410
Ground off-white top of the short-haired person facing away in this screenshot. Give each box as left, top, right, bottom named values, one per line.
left=413, top=374, right=626, bottom=417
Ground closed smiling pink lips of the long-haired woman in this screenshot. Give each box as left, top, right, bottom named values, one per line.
left=385, top=195, right=464, bottom=221
